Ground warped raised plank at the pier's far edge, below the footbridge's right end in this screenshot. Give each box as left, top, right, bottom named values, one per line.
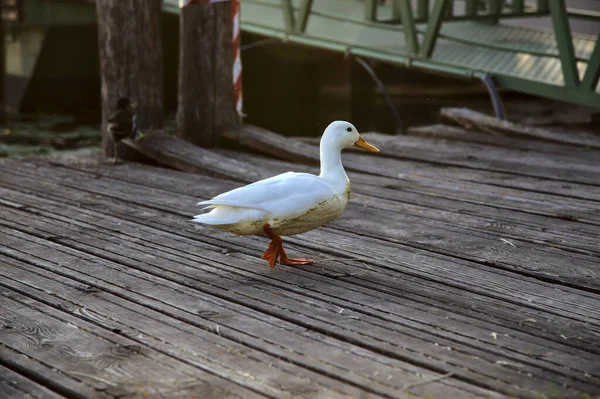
left=440, top=108, right=600, bottom=148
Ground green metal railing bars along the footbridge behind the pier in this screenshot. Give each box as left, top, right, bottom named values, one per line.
left=262, top=0, right=600, bottom=107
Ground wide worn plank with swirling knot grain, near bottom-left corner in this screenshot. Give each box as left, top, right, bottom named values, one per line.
left=0, top=286, right=258, bottom=397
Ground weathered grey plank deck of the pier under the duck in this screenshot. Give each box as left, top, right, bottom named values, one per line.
left=0, top=114, right=600, bottom=399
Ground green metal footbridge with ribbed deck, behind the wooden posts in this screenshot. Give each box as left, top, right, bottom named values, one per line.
left=10, top=0, right=600, bottom=108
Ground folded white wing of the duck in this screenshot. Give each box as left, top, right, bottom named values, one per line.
left=198, top=172, right=336, bottom=217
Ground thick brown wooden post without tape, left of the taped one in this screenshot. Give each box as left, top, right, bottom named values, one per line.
left=96, top=0, right=164, bottom=158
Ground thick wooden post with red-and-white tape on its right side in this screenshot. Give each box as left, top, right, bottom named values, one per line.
left=177, top=1, right=240, bottom=147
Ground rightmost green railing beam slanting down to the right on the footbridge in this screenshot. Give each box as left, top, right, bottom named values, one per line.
left=549, top=0, right=579, bottom=87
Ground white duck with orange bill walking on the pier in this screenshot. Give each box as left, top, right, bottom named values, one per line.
left=193, top=121, right=379, bottom=270
